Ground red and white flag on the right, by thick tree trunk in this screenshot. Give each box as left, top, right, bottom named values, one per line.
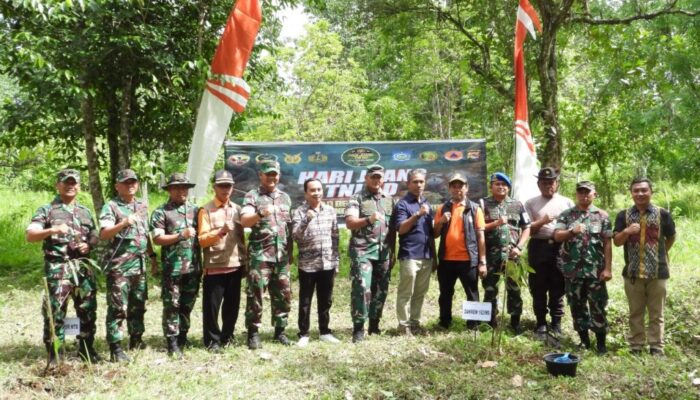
left=513, top=0, right=542, bottom=202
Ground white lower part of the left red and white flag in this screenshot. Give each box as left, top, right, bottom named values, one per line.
left=187, top=89, right=233, bottom=198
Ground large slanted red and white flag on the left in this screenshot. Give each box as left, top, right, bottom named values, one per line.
left=187, top=0, right=262, bottom=197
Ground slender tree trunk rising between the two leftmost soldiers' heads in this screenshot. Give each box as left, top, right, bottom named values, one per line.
left=80, top=81, right=105, bottom=213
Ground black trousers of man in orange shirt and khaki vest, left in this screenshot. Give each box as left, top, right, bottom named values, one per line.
left=202, top=268, right=243, bottom=347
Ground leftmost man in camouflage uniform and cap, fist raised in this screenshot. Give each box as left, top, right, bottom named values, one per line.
left=26, top=169, right=100, bottom=366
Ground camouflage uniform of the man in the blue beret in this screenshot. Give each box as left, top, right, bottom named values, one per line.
left=481, top=196, right=530, bottom=321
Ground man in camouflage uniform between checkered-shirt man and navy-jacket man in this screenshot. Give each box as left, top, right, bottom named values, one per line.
left=345, top=165, right=396, bottom=343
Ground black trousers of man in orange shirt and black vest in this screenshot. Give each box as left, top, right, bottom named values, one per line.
left=438, top=260, right=479, bottom=327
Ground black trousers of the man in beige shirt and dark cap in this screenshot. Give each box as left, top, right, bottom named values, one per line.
left=528, top=239, right=564, bottom=326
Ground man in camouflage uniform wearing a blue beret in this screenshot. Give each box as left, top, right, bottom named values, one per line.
left=481, top=172, right=530, bottom=334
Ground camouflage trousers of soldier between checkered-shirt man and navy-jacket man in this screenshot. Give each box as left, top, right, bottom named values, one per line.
left=350, top=259, right=391, bottom=324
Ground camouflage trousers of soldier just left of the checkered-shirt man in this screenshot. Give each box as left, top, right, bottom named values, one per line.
left=245, top=258, right=292, bottom=331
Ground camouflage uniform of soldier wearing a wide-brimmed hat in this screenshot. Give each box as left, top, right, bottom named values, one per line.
left=151, top=201, right=202, bottom=336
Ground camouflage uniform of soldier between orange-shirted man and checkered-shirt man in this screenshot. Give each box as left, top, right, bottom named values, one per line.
left=241, top=187, right=292, bottom=332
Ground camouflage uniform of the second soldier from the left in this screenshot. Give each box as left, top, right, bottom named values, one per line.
left=100, top=196, right=148, bottom=343
